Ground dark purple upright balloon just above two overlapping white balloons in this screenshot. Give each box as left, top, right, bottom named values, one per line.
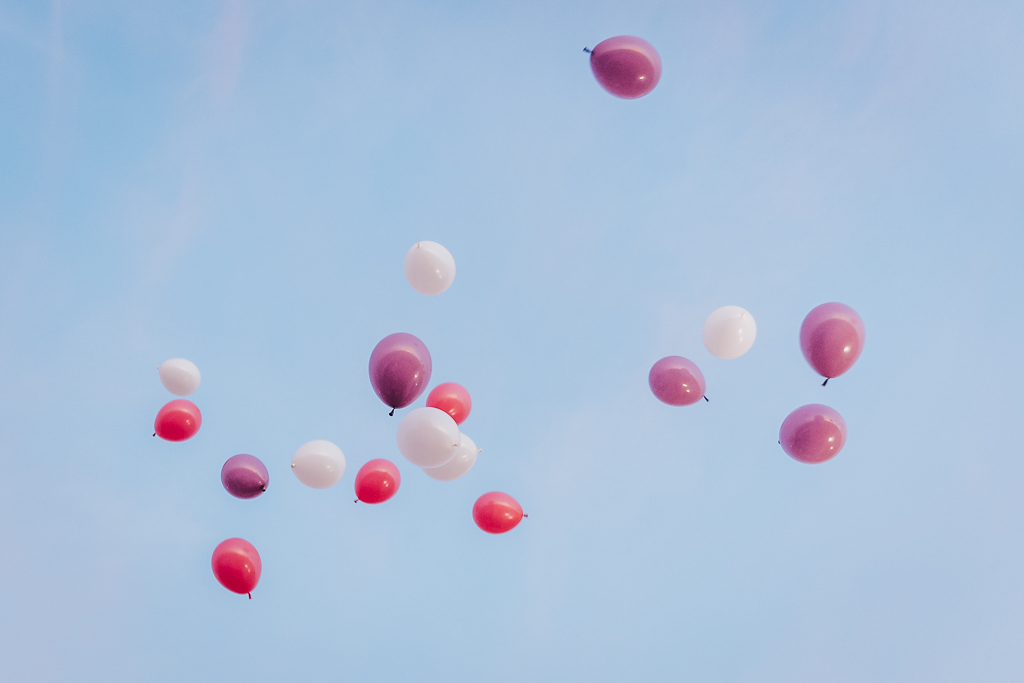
left=370, top=332, right=430, bottom=415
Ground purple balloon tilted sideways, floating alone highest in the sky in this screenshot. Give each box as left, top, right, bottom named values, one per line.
left=590, top=36, right=662, bottom=99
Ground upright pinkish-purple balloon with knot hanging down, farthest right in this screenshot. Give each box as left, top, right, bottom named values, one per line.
left=800, top=303, right=864, bottom=386
